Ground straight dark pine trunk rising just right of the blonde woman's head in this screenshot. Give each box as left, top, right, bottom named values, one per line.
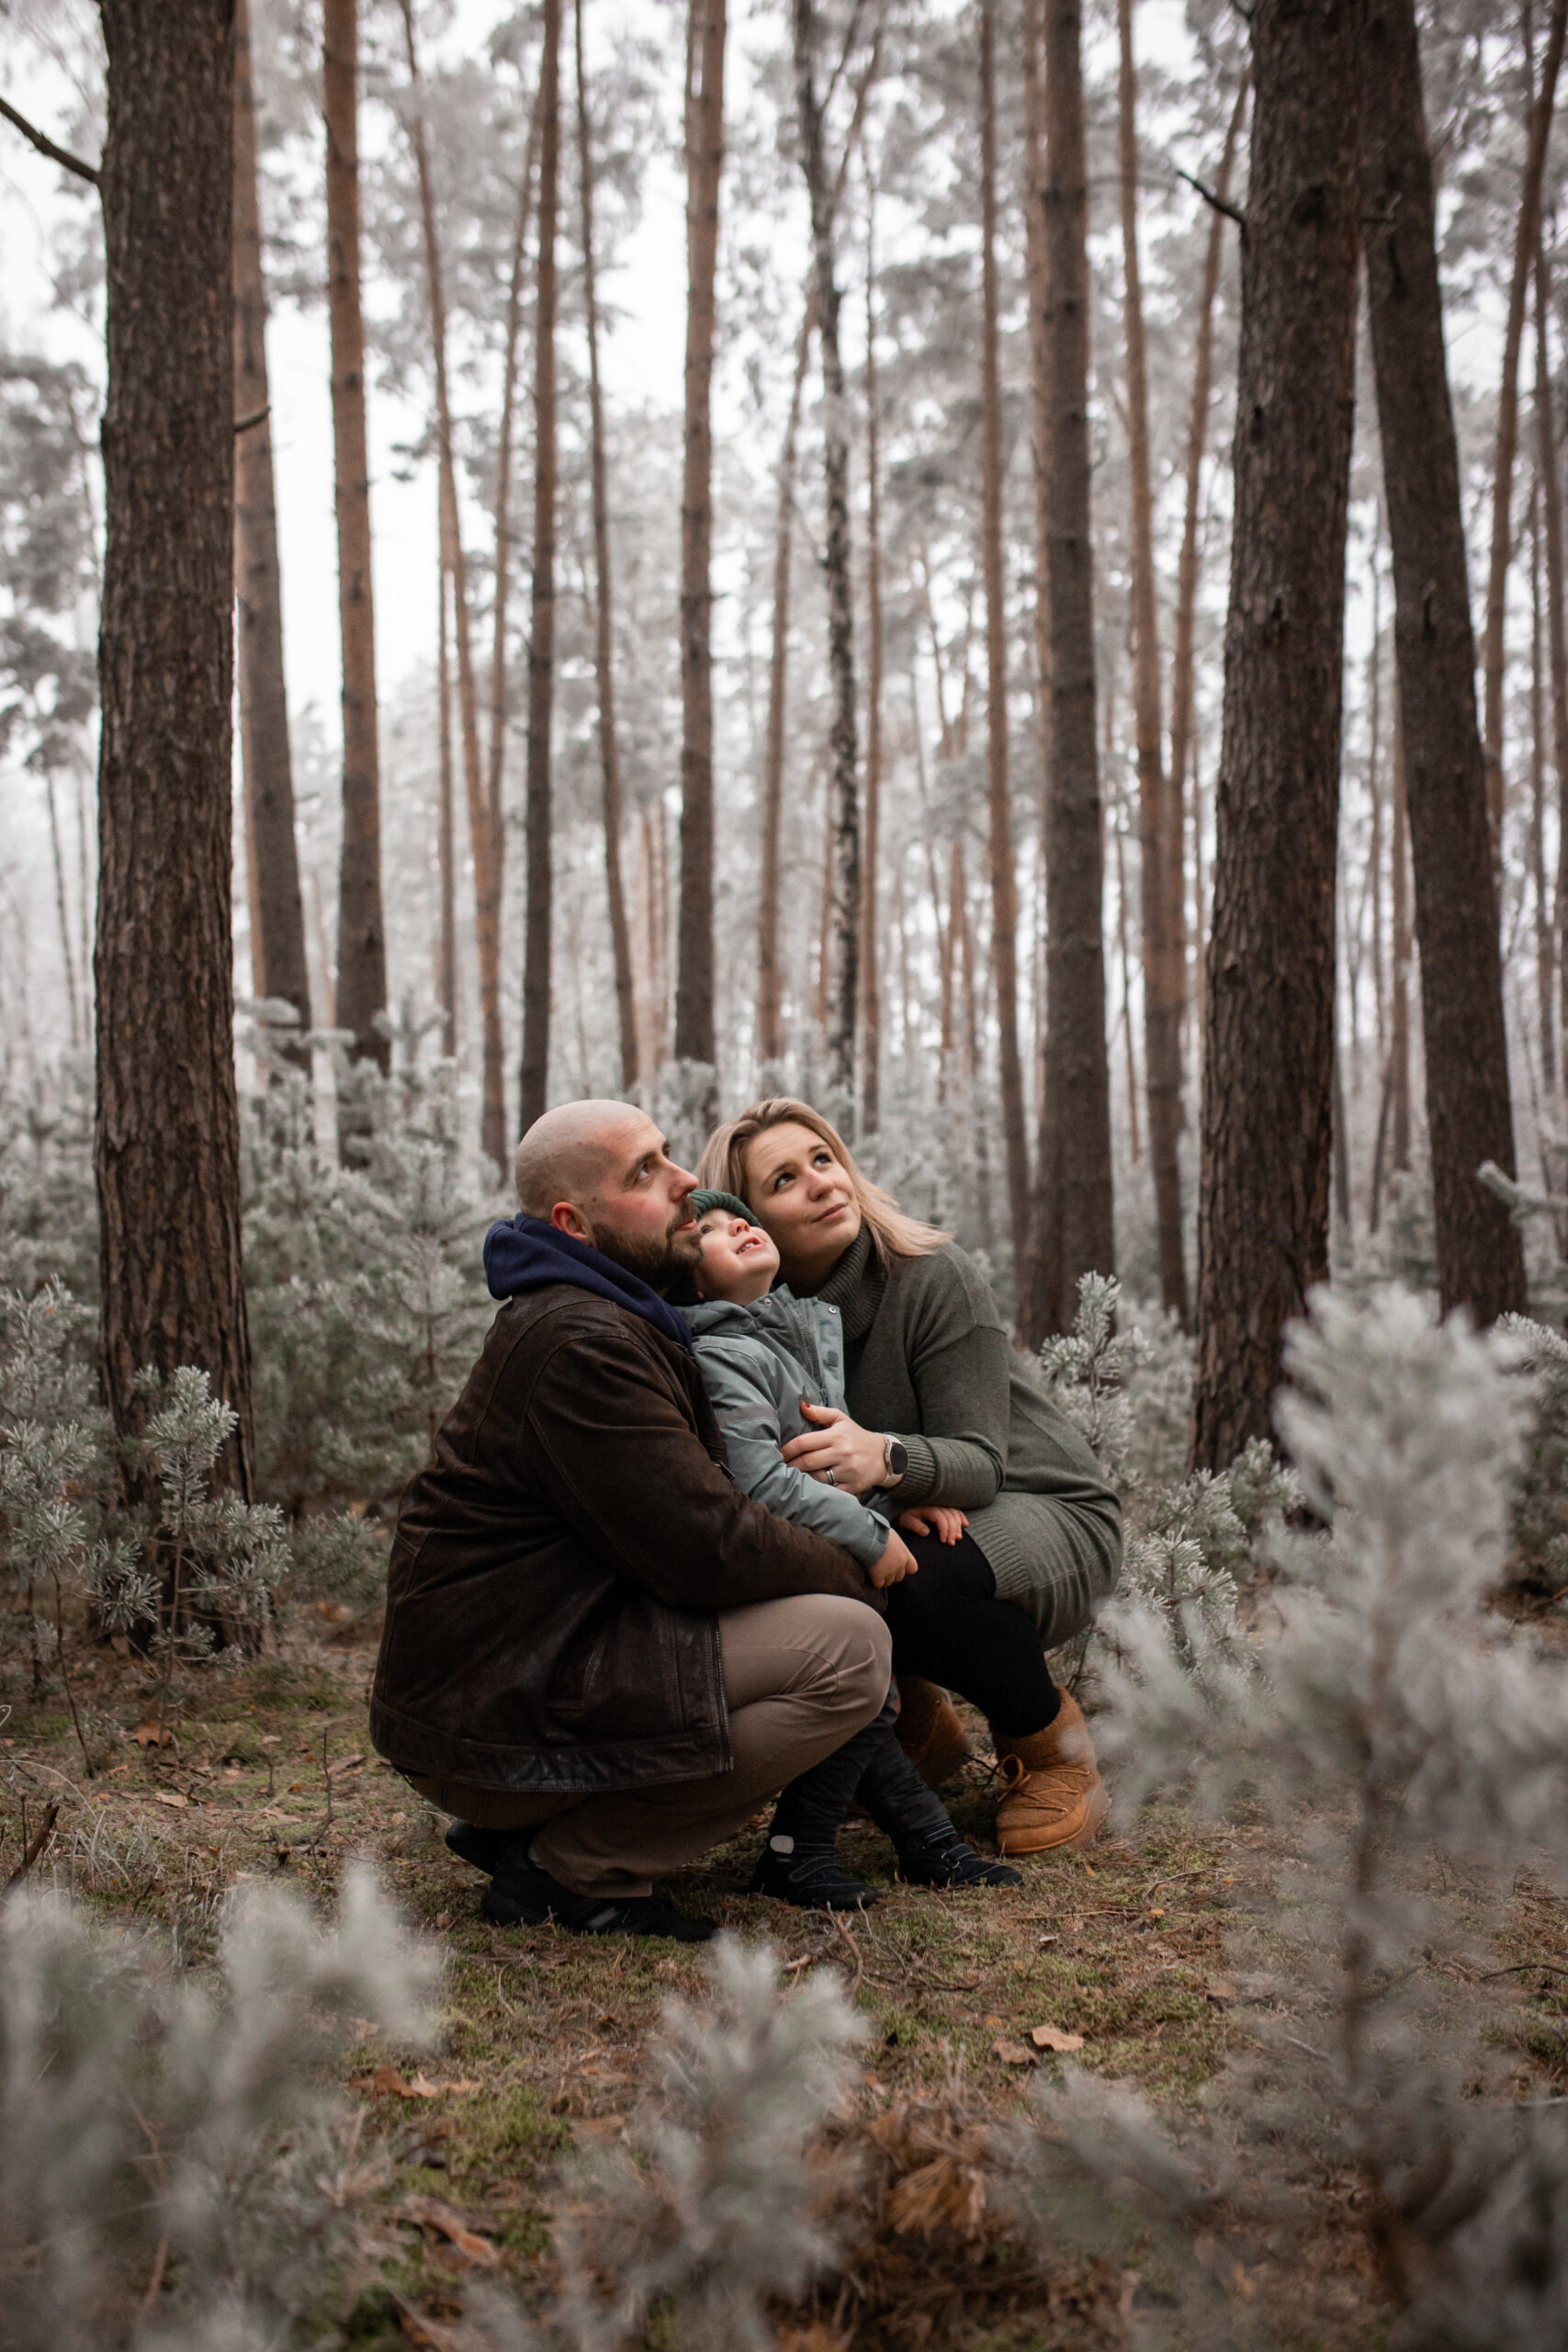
left=1022, top=0, right=1117, bottom=1345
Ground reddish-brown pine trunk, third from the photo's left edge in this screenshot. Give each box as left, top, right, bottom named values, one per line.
left=322, top=0, right=392, bottom=1101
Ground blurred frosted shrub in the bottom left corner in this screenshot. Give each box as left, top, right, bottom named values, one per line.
left=0, top=1874, right=434, bottom=2352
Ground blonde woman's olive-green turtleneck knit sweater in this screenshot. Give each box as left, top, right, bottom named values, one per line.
left=795, top=1230, right=1122, bottom=1649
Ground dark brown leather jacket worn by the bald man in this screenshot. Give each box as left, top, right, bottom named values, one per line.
left=371, top=1282, right=882, bottom=1792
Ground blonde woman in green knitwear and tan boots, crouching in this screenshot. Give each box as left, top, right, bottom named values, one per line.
left=698, top=1096, right=1122, bottom=1853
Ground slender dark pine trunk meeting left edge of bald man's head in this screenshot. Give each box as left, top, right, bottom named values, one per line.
left=517, top=0, right=562, bottom=1136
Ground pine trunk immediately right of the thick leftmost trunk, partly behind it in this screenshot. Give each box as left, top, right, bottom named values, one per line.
left=235, top=0, right=310, bottom=1070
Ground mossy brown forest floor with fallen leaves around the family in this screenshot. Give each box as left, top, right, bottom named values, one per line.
left=0, top=1604, right=1568, bottom=2352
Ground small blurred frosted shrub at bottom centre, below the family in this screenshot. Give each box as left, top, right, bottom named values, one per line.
left=533, top=1938, right=865, bottom=2352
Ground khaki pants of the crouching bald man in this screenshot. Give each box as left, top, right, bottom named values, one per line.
left=409, top=1592, right=894, bottom=1900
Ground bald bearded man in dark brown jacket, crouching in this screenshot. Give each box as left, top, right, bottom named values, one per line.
left=371, top=1103, right=891, bottom=1943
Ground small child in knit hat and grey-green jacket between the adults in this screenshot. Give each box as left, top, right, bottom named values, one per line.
left=682, top=1190, right=1022, bottom=1910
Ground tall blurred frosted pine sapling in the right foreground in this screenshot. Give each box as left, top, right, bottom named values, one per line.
left=1042, top=1289, right=1568, bottom=2352
